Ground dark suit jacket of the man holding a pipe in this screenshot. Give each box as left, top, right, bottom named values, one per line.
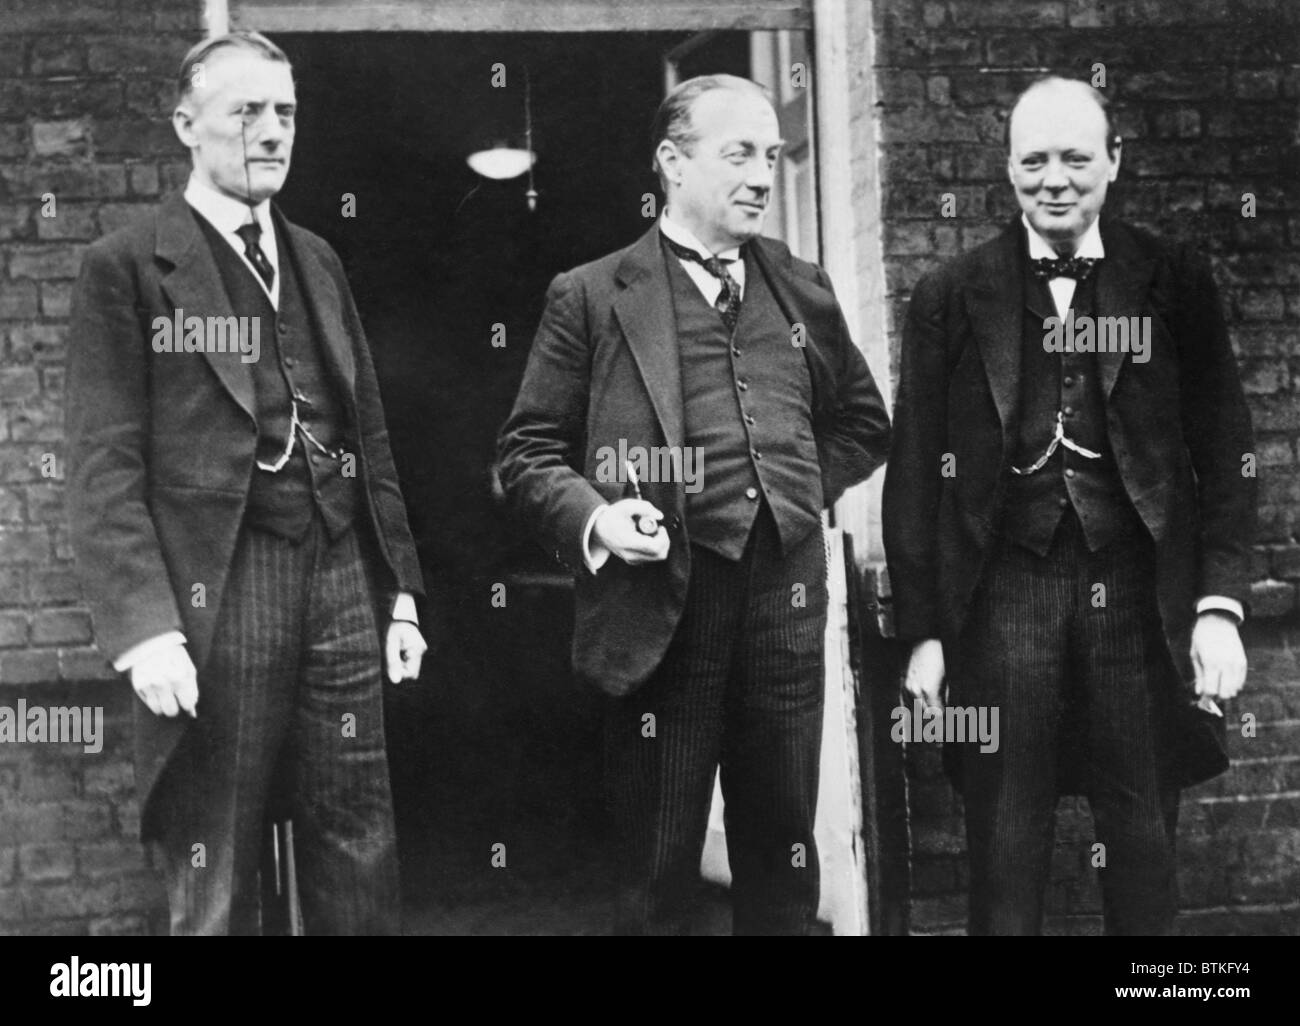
left=498, top=226, right=889, bottom=694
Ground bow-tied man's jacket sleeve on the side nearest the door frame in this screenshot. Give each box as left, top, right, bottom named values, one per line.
left=883, top=276, right=948, bottom=641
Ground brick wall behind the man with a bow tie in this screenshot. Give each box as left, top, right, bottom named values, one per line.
left=875, top=0, right=1300, bottom=932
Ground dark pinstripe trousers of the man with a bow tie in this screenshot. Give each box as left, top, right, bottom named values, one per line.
left=952, top=510, right=1178, bottom=935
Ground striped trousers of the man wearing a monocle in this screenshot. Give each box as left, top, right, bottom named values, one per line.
left=150, top=518, right=399, bottom=935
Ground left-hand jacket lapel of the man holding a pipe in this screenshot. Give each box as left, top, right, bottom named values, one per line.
left=614, top=225, right=685, bottom=446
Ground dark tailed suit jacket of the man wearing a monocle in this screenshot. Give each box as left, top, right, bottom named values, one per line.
left=66, top=194, right=423, bottom=821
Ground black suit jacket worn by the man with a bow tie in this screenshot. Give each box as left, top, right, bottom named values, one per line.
left=884, top=215, right=1256, bottom=785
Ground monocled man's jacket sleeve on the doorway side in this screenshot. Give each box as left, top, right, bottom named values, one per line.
left=326, top=247, right=424, bottom=595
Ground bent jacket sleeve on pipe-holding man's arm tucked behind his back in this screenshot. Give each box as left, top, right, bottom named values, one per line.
left=818, top=268, right=891, bottom=506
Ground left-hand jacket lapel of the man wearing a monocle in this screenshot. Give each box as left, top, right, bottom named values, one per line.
left=153, top=192, right=257, bottom=420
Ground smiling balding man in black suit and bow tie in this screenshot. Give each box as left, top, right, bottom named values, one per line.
left=884, top=78, right=1255, bottom=934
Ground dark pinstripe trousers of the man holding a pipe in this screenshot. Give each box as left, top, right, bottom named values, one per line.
left=605, top=503, right=827, bottom=935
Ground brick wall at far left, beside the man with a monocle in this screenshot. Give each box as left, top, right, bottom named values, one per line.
left=0, top=0, right=202, bottom=934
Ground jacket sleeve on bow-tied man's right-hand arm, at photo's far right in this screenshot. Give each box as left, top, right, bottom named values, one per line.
left=1175, top=250, right=1258, bottom=606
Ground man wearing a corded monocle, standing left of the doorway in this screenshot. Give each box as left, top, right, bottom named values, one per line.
left=68, top=33, right=424, bottom=934
